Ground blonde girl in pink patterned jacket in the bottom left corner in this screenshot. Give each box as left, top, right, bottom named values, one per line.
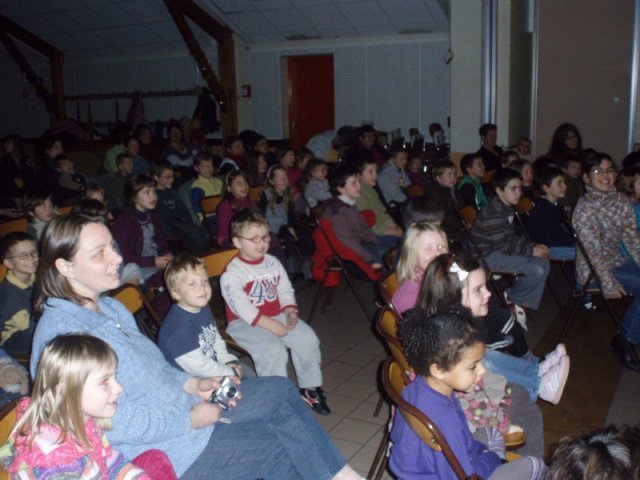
left=0, top=335, right=176, bottom=480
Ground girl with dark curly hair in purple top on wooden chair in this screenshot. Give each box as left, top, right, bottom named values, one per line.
left=389, top=308, right=545, bottom=480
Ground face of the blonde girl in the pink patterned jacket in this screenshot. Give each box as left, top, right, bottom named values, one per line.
left=81, top=364, right=122, bottom=421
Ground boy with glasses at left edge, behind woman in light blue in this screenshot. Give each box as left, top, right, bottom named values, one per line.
left=0, top=232, right=38, bottom=357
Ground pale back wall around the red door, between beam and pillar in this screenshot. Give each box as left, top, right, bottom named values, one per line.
left=236, top=34, right=450, bottom=138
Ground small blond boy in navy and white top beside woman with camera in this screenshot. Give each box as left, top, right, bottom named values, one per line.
left=158, top=253, right=255, bottom=378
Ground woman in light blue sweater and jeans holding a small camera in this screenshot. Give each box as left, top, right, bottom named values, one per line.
left=31, top=213, right=360, bottom=480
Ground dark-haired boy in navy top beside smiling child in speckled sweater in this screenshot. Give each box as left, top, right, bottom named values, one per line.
left=526, top=167, right=576, bottom=260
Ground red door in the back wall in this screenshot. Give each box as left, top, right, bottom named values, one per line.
left=287, top=55, right=335, bottom=148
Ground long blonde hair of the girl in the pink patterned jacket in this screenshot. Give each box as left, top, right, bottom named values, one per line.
left=13, top=334, right=118, bottom=448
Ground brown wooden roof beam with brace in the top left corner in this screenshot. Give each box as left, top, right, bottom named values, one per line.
left=0, top=14, right=65, bottom=119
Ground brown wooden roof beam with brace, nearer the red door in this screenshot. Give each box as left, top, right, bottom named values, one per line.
left=164, top=0, right=238, bottom=135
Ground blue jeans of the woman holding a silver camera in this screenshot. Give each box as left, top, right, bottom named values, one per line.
left=180, top=377, right=346, bottom=480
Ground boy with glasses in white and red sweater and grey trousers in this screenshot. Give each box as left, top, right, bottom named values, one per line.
left=220, top=209, right=331, bottom=415
